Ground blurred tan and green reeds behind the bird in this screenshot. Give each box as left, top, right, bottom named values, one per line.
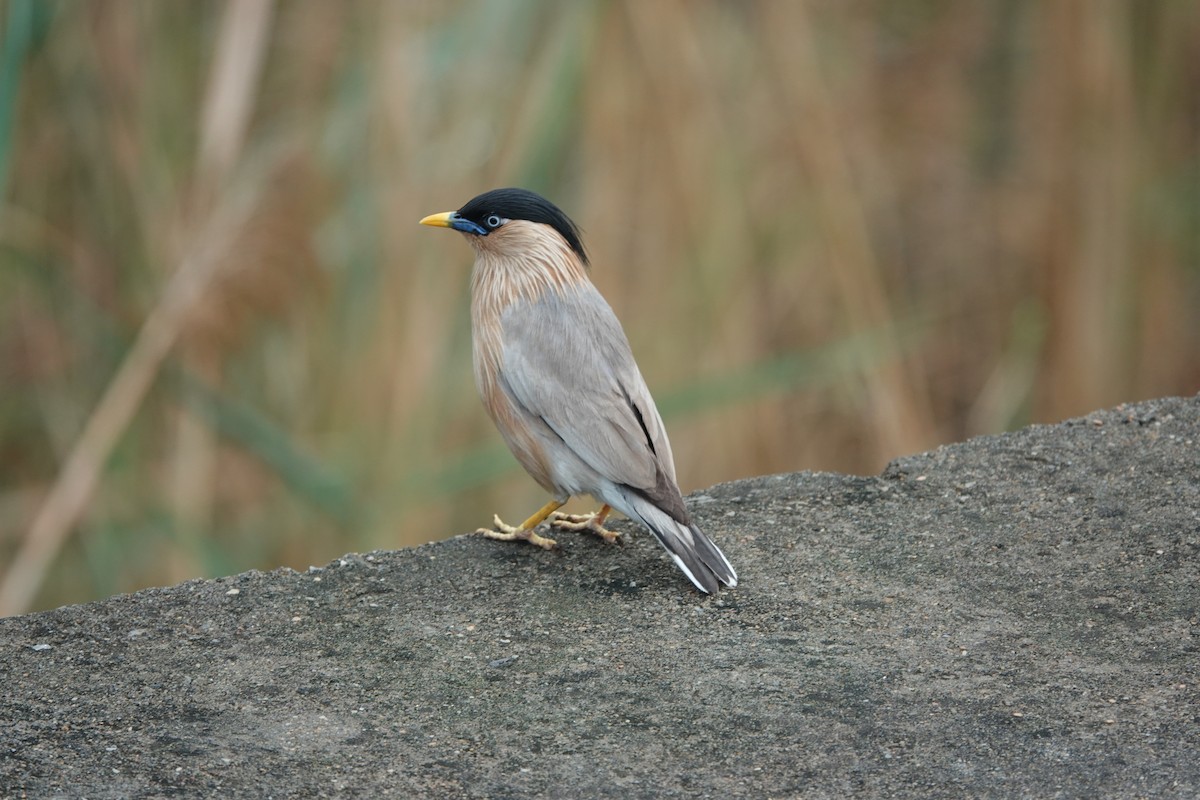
left=0, top=0, right=1200, bottom=613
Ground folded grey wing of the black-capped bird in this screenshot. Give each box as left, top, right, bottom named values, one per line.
left=500, top=285, right=678, bottom=491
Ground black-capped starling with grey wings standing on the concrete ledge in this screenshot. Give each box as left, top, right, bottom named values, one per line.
left=421, top=188, right=738, bottom=594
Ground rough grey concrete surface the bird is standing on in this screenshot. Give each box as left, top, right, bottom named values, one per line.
left=0, top=398, right=1200, bottom=798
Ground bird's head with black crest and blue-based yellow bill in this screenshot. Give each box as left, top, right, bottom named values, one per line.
left=421, top=188, right=588, bottom=265
